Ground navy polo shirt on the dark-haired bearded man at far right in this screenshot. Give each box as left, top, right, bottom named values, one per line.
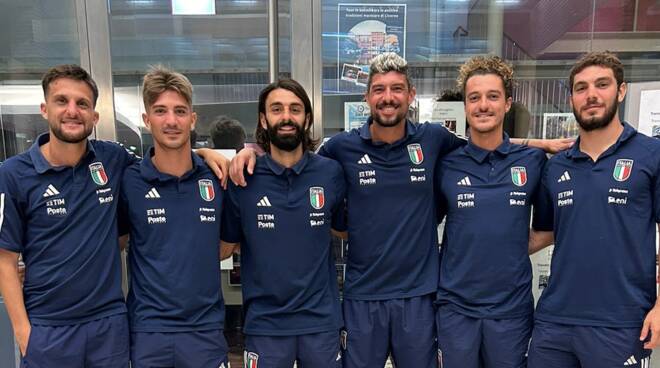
left=537, top=123, right=660, bottom=328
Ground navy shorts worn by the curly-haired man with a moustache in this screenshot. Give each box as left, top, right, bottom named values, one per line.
left=436, top=306, right=534, bottom=368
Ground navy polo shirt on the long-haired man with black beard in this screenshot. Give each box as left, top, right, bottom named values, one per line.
left=221, top=153, right=345, bottom=336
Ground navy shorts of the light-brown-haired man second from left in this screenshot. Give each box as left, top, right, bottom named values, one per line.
left=131, top=330, right=229, bottom=368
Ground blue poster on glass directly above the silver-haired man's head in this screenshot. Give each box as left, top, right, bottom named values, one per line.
left=337, top=4, right=406, bottom=86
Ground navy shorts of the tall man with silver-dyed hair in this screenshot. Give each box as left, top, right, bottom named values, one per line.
left=342, top=295, right=438, bottom=368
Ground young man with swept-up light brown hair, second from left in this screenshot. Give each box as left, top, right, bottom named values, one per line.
left=120, top=67, right=228, bottom=368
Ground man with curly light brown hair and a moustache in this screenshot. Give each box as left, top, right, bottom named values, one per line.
left=435, top=56, right=552, bottom=368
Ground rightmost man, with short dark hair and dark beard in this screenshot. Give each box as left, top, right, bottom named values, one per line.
left=529, top=52, right=660, bottom=368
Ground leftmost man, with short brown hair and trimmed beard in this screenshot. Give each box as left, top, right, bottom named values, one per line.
left=0, top=65, right=135, bottom=367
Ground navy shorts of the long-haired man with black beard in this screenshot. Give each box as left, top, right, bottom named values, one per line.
left=243, top=331, right=342, bottom=368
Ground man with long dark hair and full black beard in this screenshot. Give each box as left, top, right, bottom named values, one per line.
left=221, top=79, right=345, bottom=368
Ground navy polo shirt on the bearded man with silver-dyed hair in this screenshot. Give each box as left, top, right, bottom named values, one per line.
left=319, top=119, right=465, bottom=300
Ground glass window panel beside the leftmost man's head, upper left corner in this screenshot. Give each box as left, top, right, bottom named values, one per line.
left=0, top=0, right=80, bottom=161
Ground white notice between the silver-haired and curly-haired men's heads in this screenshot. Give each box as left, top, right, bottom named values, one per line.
left=418, top=97, right=466, bottom=136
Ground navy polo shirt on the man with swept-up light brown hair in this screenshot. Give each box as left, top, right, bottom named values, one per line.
left=120, top=148, right=225, bottom=332
